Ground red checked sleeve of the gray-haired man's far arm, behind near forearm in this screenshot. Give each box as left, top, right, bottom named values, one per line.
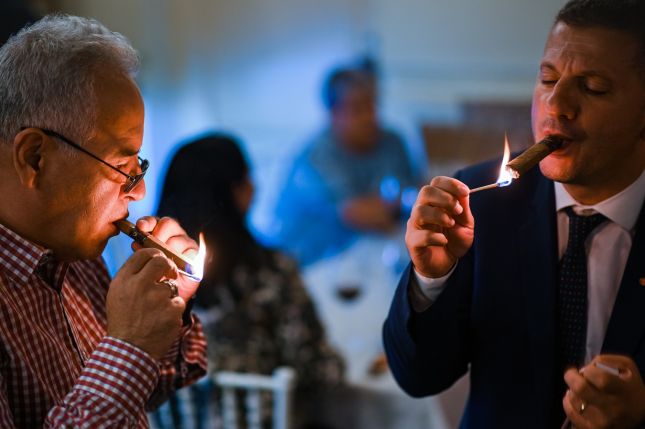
left=146, top=314, right=207, bottom=411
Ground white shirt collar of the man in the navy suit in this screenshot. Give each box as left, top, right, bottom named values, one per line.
left=555, top=170, right=645, bottom=231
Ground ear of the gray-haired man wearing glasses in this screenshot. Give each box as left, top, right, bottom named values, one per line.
left=12, top=128, right=46, bottom=188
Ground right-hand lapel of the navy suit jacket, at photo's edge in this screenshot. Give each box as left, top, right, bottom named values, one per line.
left=603, top=203, right=645, bottom=356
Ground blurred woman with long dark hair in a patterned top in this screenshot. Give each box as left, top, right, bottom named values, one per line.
left=153, top=134, right=344, bottom=427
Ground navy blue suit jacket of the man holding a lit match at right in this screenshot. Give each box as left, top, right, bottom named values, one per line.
left=383, top=161, right=645, bottom=429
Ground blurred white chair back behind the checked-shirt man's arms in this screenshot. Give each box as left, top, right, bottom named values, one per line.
left=212, top=367, right=296, bottom=429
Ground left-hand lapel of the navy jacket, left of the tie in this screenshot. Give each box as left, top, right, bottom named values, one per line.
left=518, top=175, right=558, bottom=415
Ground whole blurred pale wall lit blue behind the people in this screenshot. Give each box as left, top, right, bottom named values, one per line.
left=59, top=0, right=564, bottom=268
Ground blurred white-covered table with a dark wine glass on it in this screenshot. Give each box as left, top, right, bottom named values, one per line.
left=303, top=232, right=448, bottom=429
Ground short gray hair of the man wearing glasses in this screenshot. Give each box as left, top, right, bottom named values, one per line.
left=0, top=14, right=139, bottom=144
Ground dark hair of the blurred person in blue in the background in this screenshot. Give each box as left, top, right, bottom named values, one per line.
left=322, top=67, right=376, bottom=110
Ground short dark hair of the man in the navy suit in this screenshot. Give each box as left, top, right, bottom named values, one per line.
left=555, top=0, right=645, bottom=70
